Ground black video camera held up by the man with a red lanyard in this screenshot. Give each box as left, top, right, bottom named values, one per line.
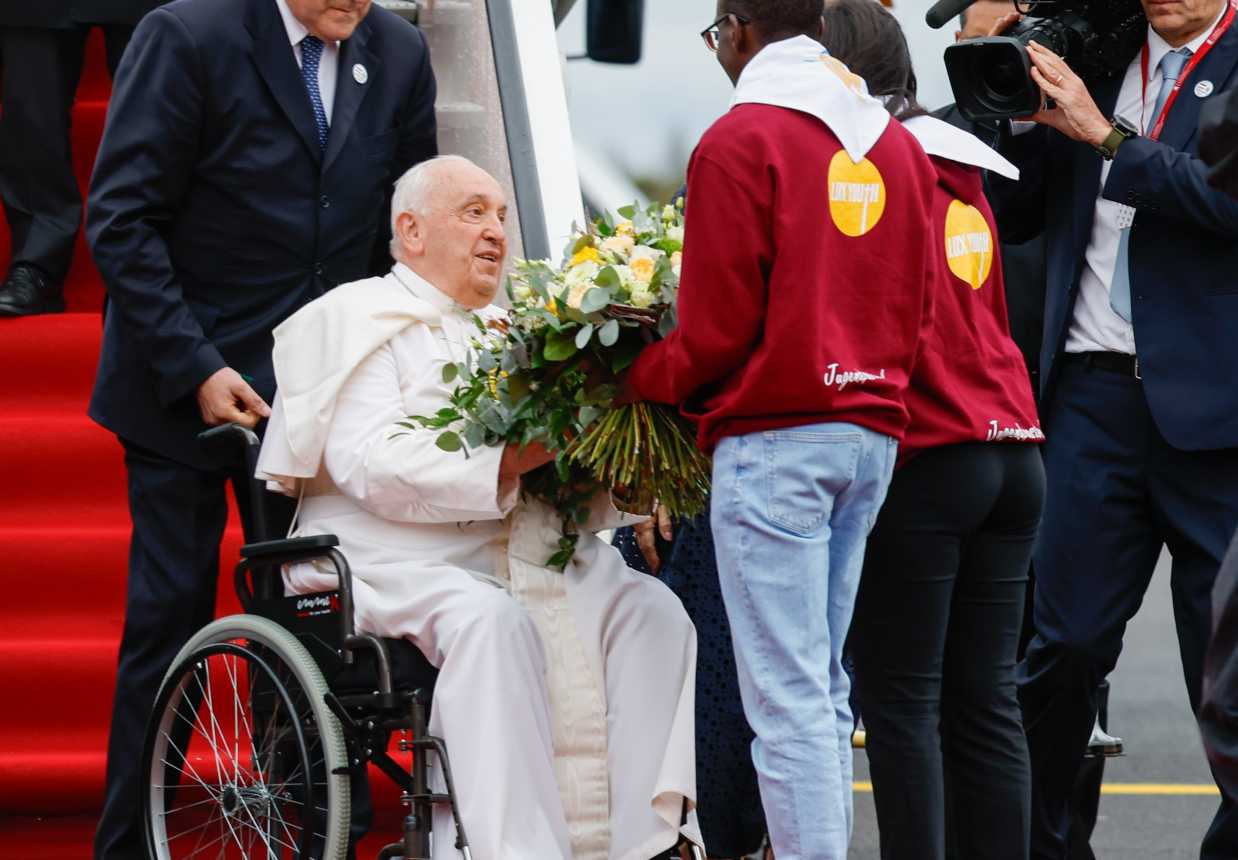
left=925, top=0, right=1148, bottom=120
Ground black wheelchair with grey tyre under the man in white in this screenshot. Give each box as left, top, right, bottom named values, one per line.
left=142, top=424, right=704, bottom=860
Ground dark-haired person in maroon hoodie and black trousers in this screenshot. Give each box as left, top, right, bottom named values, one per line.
left=823, top=0, right=1045, bottom=860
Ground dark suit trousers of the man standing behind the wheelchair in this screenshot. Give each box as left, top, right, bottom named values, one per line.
left=94, top=441, right=293, bottom=860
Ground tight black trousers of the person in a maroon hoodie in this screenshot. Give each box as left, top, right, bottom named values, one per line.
left=851, top=443, right=1045, bottom=860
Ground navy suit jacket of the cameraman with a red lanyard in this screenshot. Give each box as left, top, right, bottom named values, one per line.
left=989, top=27, right=1238, bottom=450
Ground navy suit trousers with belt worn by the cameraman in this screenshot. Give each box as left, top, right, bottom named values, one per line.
left=1018, top=355, right=1238, bottom=860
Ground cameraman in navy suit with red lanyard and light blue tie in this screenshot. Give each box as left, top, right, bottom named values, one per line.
left=992, top=0, right=1238, bottom=860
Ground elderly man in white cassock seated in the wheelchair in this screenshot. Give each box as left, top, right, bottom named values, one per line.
left=259, top=157, right=699, bottom=860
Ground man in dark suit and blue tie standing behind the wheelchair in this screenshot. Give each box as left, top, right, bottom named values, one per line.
left=87, top=0, right=437, bottom=860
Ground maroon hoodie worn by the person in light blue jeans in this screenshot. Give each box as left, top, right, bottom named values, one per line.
left=629, top=104, right=937, bottom=450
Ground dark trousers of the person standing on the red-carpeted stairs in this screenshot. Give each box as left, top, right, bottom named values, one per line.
left=0, top=25, right=134, bottom=283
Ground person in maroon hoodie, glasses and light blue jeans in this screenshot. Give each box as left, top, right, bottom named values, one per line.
left=629, top=0, right=936, bottom=860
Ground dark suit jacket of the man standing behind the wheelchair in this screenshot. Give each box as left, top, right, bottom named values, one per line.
left=87, top=0, right=437, bottom=465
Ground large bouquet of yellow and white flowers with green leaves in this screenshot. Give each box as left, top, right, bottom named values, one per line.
left=401, top=202, right=709, bottom=569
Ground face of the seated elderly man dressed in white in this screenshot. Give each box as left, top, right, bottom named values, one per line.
left=397, top=163, right=508, bottom=308
